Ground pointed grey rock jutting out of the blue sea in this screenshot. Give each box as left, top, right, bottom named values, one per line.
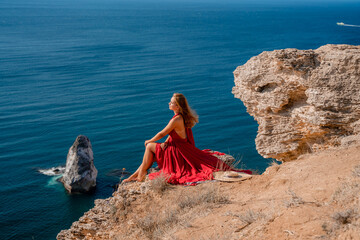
left=60, top=135, right=98, bottom=193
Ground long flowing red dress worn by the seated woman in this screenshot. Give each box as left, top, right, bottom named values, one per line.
left=149, top=115, right=251, bottom=184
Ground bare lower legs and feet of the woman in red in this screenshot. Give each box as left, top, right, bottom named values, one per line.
left=123, top=143, right=156, bottom=182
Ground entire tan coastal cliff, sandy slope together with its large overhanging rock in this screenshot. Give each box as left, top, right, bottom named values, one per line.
left=57, top=45, right=360, bottom=240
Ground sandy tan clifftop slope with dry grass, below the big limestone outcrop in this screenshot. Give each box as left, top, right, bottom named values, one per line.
left=58, top=143, right=360, bottom=240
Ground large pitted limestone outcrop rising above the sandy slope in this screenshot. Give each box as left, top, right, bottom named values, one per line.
left=233, top=45, right=360, bottom=161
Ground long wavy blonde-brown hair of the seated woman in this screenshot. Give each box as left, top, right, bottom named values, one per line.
left=173, top=93, right=199, bottom=128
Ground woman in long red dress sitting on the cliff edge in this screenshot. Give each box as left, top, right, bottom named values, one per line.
left=123, top=93, right=251, bottom=184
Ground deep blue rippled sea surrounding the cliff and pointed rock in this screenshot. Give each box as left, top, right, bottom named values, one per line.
left=0, top=0, right=360, bottom=239
